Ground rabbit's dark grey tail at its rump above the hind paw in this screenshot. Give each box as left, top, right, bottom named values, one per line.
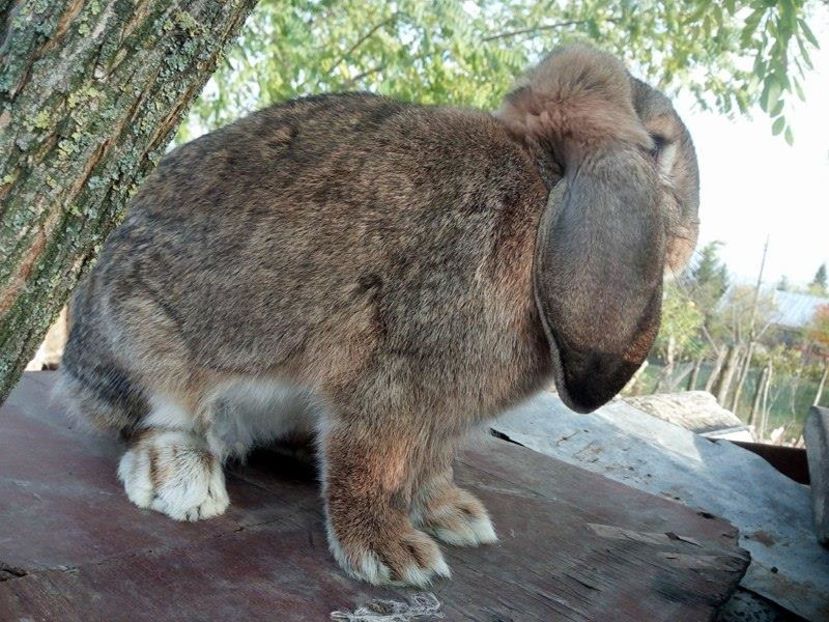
left=55, top=352, right=149, bottom=436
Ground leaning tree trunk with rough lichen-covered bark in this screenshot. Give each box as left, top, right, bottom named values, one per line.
left=0, top=0, right=255, bottom=403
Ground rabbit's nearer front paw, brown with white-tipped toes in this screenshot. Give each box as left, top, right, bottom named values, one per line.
left=328, top=523, right=451, bottom=587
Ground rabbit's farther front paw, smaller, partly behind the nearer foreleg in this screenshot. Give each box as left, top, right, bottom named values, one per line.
left=412, top=483, right=498, bottom=546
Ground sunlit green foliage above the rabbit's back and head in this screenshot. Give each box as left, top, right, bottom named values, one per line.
left=180, top=0, right=818, bottom=142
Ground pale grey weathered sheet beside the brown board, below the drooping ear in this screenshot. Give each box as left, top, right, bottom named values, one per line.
left=492, top=393, right=829, bottom=622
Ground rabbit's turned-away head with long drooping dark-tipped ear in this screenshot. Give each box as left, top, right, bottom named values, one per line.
left=498, top=45, right=699, bottom=412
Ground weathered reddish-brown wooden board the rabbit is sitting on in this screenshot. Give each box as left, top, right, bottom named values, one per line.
left=0, top=372, right=748, bottom=622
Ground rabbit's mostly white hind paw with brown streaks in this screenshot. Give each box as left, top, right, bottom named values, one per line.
left=118, top=431, right=230, bottom=521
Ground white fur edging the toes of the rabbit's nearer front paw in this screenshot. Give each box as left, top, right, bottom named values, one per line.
left=328, top=523, right=452, bottom=587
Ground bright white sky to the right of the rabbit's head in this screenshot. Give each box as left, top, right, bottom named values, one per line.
left=674, top=12, right=829, bottom=285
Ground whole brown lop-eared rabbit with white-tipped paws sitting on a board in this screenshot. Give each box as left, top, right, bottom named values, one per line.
left=55, top=45, right=699, bottom=586
